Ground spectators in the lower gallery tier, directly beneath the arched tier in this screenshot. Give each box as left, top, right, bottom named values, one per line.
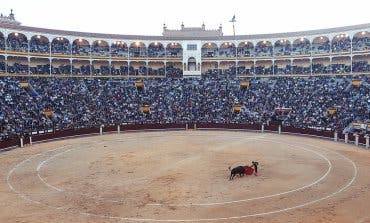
left=0, top=60, right=370, bottom=77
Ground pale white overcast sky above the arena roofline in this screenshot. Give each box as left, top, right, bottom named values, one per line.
left=0, top=0, right=370, bottom=35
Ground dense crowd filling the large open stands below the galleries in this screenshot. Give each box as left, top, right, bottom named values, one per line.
left=0, top=75, right=370, bottom=140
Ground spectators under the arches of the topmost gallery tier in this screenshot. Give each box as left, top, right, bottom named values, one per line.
left=0, top=33, right=370, bottom=58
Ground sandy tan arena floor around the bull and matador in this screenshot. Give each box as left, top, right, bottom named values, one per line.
left=0, top=131, right=370, bottom=223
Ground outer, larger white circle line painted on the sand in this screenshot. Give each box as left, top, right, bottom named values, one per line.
left=7, top=132, right=358, bottom=222
